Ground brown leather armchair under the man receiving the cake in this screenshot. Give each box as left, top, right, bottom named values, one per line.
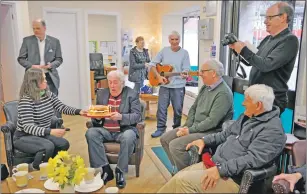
left=86, top=101, right=146, bottom=177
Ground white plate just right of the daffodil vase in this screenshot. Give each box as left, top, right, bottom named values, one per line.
left=75, top=173, right=104, bottom=193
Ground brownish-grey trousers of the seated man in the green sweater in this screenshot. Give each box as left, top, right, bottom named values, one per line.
left=160, top=128, right=207, bottom=171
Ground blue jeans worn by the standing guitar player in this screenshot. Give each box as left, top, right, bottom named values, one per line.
left=157, top=86, right=185, bottom=131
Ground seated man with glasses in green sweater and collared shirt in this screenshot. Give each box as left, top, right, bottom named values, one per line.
left=160, top=59, right=233, bottom=173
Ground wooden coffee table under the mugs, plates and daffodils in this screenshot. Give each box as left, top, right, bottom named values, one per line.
left=6, top=171, right=121, bottom=193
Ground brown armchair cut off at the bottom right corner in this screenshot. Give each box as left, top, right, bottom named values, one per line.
left=272, top=140, right=307, bottom=193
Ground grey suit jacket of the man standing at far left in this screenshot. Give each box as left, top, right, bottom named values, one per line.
left=17, top=35, right=63, bottom=88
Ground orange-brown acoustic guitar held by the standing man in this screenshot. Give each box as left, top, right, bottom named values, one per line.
left=148, top=63, right=198, bottom=86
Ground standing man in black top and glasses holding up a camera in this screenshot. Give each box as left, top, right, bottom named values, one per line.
left=229, top=2, right=299, bottom=114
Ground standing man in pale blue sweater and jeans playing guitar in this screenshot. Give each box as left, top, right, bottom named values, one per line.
left=149, top=31, right=190, bottom=137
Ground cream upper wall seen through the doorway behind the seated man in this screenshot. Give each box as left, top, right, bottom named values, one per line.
left=88, top=15, right=117, bottom=41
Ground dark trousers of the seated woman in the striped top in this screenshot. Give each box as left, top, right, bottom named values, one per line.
left=14, top=135, right=69, bottom=169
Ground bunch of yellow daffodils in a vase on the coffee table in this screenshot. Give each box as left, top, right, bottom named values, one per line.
left=48, top=151, right=87, bottom=193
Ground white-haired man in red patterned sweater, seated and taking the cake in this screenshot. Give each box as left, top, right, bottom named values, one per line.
left=85, top=71, right=142, bottom=188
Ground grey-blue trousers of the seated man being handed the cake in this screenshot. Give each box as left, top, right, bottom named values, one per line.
left=85, top=127, right=137, bottom=172
